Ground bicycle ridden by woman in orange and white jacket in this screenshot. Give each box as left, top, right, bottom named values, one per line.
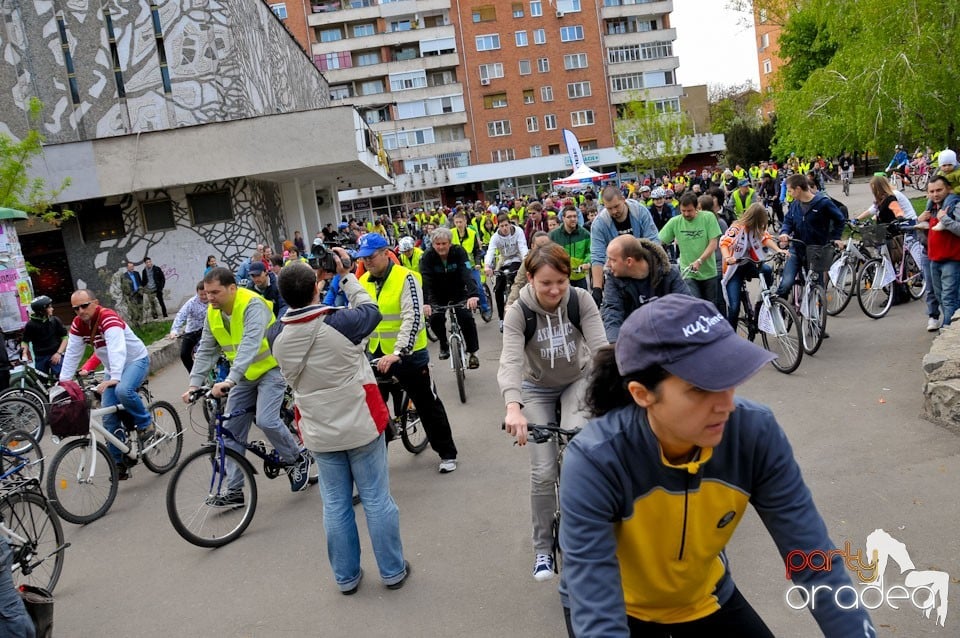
left=737, top=254, right=804, bottom=374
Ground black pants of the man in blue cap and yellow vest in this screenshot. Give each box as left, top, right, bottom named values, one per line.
left=374, top=349, right=457, bottom=459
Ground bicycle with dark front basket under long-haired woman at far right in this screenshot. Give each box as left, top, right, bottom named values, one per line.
left=857, top=224, right=926, bottom=319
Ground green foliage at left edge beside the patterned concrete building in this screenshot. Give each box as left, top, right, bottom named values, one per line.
left=0, top=98, right=73, bottom=225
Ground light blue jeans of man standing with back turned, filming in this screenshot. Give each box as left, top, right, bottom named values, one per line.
left=313, top=434, right=407, bottom=591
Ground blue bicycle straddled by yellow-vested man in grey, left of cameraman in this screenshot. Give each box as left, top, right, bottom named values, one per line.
left=166, top=386, right=313, bottom=547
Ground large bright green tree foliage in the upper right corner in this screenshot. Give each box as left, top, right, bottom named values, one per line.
left=773, top=0, right=960, bottom=156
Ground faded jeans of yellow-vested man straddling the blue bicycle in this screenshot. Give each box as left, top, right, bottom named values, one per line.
left=224, top=368, right=300, bottom=490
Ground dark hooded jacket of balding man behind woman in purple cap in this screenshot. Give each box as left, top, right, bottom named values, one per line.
left=600, top=239, right=690, bottom=343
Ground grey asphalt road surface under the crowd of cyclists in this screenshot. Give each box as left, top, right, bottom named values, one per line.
left=52, top=184, right=960, bottom=638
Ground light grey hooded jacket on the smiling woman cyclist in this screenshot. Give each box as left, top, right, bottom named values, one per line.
left=497, top=286, right=607, bottom=405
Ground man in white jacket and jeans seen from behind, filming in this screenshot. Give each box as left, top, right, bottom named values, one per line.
left=273, top=258, right=410, bottom=596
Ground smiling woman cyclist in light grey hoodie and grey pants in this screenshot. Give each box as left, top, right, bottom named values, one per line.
left=497, top=243, right=607, bottom=581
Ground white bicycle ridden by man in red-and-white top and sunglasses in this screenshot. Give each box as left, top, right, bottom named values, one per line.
left=47, top=384, right=183, bottom=525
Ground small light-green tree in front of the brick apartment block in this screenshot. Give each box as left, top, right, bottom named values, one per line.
left=614, top=96, right=693, bottom=173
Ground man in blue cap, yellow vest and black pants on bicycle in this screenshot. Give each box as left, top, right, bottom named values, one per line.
left=357, top=231, right=462, bottom=474
